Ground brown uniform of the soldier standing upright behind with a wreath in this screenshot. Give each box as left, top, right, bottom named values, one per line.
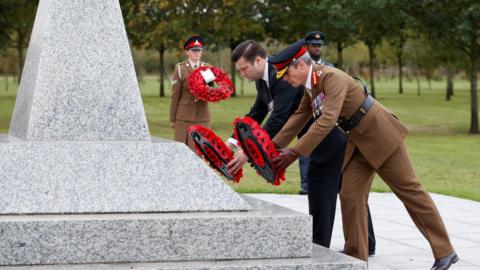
left=170, top=61, right=210, bottom=150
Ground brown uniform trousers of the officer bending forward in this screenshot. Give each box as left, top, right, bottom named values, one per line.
left=340, top=143, right=453, bottom=261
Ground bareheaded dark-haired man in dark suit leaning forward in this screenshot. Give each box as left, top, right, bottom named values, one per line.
left=227, top=40, right=346, bottom=247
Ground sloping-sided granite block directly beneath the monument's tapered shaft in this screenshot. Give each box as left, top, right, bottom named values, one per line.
left=0, top=136, right=249, bottom=214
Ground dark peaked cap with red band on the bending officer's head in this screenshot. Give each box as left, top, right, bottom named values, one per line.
left=268, top=39, right=307, bottom=79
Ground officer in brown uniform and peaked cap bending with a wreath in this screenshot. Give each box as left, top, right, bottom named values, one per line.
left=269, top=40, right=458, bottom=270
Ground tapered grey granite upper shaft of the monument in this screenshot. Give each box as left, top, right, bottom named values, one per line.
left=10, top=0, right=150, bottom=141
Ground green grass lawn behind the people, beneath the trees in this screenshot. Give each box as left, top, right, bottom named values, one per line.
left=0, top=77, right=480, bottom=201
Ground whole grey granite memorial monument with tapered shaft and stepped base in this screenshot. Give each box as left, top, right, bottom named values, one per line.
left=0, top=0, right=366, bottom=269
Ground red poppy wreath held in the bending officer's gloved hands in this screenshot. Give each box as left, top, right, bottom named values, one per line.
left=233, top=116, right=286, bottom=186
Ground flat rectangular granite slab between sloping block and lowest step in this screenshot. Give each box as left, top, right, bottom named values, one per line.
left=0, top=197, right=312, bottom=265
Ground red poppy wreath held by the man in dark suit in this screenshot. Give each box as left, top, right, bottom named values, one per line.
left=188, top=125, right=243, bottom=183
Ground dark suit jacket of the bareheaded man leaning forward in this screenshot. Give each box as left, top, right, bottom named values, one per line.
left=240, top=64, right=303, bottom=138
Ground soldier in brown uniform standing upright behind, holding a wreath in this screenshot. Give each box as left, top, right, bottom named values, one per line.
left=170, top=36, right=210, bottom=150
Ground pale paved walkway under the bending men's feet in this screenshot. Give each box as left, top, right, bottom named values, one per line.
left=248, top=193, right=480, bottom=270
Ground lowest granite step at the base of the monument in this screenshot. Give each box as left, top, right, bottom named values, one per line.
left=0, top=244, right=367, bottom=270
